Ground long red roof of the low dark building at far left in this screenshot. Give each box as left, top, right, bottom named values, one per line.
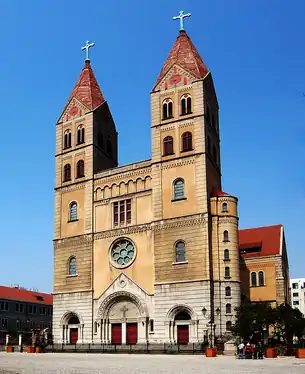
left=0, top=286, right=53, bottom=305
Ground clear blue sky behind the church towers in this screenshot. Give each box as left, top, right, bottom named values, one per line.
left=0, top=0, right=305, bottom=292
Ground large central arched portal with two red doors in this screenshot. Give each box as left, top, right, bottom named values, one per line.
left=98, top=292, right=148, bottom=344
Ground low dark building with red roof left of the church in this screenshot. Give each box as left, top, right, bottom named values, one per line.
left=0, top=286, right=53, bottom=344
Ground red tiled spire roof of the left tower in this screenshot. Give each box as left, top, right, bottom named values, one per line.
left=69, top=61, right=105, bottom=110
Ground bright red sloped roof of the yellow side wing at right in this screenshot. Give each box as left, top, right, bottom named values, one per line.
left=238, top=225, right=283, bottom=258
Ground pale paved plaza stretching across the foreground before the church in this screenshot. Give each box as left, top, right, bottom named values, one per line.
left=0, top=352, right=305, bottom=374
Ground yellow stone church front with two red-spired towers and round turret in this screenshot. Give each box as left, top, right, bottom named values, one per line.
left=53, top=31, right=240, bottom=344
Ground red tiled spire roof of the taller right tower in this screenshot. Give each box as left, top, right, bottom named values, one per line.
left=154, top=31, right=209, bottom=88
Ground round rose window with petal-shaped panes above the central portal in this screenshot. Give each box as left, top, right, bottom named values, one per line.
left=110, top=239, right=136, bottom=268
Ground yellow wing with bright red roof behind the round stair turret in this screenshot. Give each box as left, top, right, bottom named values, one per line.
left=239, top=225, right=290, bottom=305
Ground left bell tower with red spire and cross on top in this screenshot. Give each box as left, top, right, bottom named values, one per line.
left=53, top=42, right=118, bottom=341
